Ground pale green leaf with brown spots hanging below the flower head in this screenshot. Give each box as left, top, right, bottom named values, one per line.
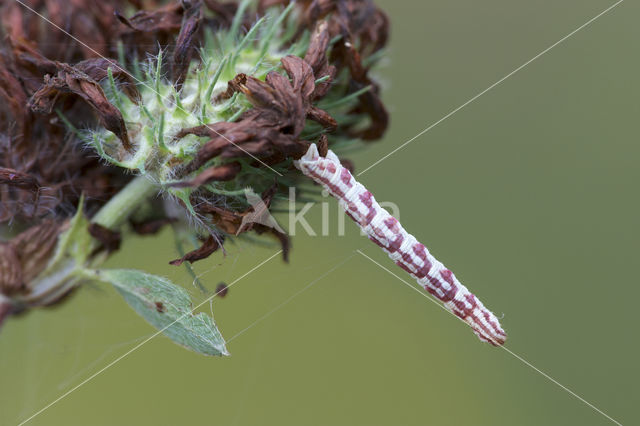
left=95, top=269, right=229, bottom=355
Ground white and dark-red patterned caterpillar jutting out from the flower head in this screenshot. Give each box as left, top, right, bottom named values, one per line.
left=295, top=144, right=507, bottom=346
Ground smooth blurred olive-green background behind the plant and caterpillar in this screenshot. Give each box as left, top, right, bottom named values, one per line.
left=0, top=0, right=640, bottom=426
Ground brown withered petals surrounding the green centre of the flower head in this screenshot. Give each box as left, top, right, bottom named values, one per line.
left=0, top=0, right=388, bottom=323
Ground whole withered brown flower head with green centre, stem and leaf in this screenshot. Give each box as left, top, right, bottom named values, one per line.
left=0, top=0, right=388, bottom=355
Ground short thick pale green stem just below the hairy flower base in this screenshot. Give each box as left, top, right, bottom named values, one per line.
left=91, top=176, right=158, bottom=229
